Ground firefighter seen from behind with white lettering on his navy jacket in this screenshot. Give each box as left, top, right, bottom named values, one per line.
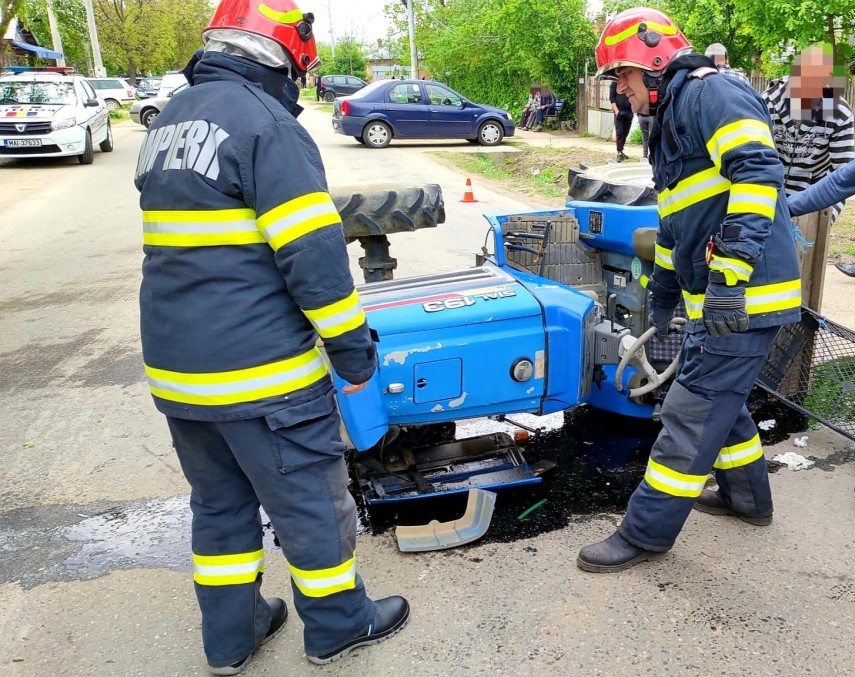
left=136, top=0, right=409, bottom=675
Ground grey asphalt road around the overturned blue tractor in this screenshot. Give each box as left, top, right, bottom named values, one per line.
left=0, top=110, right=855, bottom=677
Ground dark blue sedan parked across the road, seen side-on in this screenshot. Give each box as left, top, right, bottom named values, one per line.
left=332, top=80, right=514, bottom=148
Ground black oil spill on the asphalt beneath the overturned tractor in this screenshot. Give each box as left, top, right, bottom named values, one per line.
left=354, top=389, right=807, bottom=543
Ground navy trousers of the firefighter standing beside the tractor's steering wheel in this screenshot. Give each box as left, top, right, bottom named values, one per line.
left=618, top=320, right=778, bottom=552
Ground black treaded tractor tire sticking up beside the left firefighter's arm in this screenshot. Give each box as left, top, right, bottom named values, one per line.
left=332, top=184, right=445, bottom=242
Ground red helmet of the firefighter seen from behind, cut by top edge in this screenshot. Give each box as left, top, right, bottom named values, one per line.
left=202, top=0, right=320, bottom=73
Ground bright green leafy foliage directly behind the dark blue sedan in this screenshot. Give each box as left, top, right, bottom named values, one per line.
left=386, top=0, right=596, bottom=115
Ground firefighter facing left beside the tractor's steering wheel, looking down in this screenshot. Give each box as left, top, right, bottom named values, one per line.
left=577, top=8, right=801, bottom=572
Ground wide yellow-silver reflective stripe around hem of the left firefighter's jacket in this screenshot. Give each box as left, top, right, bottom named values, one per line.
left=145, top=348, right=327, bottom=406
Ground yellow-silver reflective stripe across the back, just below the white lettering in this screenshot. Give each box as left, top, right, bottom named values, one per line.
left=143, top=209, right=265, bottom=247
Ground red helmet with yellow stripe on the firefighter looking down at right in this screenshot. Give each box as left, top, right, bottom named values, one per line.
left=596, top=7, right=692, bottom=78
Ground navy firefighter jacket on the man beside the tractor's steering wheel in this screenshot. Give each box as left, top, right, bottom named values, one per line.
left=649, top=55, right=801, bottom=328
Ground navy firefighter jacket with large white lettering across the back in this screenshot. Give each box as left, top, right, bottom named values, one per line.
left=136, top=53, right=376, bottom=421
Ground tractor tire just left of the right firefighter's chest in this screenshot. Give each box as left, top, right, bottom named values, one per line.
left=567, top=163, right=657, bottom=207
